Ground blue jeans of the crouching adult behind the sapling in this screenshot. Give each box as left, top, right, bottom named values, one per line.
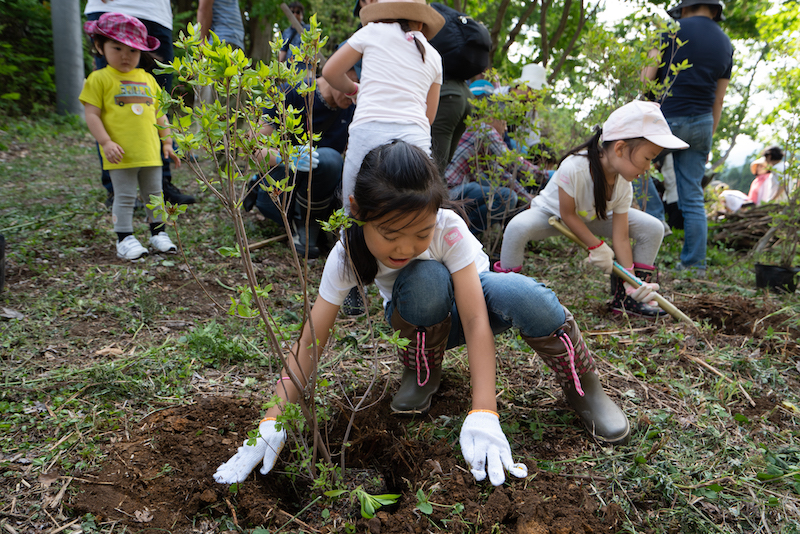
left=256, top=147, right=344, bottom=224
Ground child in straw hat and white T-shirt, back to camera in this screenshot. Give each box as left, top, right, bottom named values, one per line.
left=322, top=0, right=444, bottom=209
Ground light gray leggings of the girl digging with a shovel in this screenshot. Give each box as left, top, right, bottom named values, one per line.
left=500, top=206, right=664, bottom=269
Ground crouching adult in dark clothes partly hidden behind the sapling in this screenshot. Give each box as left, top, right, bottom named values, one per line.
left=252, top=73, right=358, bottom=258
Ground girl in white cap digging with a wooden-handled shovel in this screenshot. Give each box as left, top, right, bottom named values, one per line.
left=494, top=100, right=688, bottom=316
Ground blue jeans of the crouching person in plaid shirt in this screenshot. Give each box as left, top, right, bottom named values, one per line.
left=450, top=182, right=517, bottom=234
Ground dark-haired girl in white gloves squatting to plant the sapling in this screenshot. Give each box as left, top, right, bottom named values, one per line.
left=214, top=141, right=630, bottom=485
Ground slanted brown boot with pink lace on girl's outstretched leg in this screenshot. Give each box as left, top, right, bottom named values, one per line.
left=522, top=308, right=631, bottom=445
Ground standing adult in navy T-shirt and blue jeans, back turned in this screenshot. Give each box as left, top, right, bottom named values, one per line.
left=643, top=0, right=733, bottom=277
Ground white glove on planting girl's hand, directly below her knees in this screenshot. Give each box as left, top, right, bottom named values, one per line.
left=459, top=411, right=528, bottom=486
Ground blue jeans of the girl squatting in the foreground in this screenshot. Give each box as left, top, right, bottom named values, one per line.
left=385, top=260, right=566, bottom=349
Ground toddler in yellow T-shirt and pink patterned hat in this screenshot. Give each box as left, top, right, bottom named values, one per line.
left=80, top=13, right=180, bottom=261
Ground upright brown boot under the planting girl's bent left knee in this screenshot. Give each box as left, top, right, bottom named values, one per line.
left=390, top=309, right=451, bottom=415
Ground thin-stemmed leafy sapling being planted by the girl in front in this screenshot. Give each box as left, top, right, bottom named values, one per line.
left=153, top=17, right=344, bottom=484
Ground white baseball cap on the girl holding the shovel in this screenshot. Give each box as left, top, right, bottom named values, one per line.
left=602, top=100, right=689, bottom=149
